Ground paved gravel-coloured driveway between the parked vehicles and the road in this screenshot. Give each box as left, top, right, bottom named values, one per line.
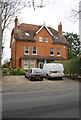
left=2, top=76, right=79, bottom=94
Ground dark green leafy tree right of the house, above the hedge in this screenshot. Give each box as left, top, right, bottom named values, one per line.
left=64, top=32, right=80, bottom=59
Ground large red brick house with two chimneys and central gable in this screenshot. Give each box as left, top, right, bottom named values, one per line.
left=10, top=17, right=68, bottom=69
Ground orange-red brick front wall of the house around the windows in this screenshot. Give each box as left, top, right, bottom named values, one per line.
left=11, top=28, right=68, bottom=68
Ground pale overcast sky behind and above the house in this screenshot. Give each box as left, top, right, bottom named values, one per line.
left=3, top=0, right=79, bottom=63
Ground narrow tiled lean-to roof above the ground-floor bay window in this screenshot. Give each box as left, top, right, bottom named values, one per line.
left=20, top=55, right=65, bottom=60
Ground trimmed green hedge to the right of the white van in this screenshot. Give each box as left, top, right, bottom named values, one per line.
left=51, top=59, right=81, bottom=77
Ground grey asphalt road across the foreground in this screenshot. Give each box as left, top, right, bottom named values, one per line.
left=3, top=88, right=79, bottom=118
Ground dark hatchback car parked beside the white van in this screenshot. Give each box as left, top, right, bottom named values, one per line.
left=25, top=68, right=44, bottom=80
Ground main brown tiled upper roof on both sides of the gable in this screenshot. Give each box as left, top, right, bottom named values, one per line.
left=13, top=23, right=68, bottom=44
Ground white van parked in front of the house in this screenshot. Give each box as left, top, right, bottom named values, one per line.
left=43, top=63, right=64, bottom=79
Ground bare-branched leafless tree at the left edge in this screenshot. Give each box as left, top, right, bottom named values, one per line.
left=0, top=0, right=54, bottom=66
